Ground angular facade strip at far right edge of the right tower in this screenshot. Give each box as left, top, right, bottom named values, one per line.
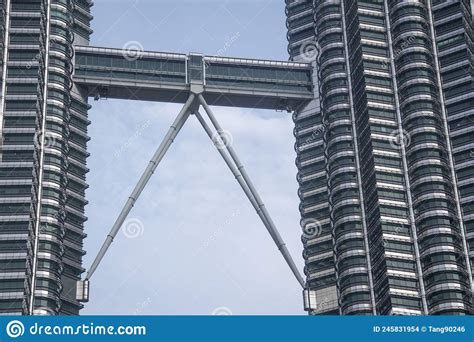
left=431, top=0, right=474, bottom=296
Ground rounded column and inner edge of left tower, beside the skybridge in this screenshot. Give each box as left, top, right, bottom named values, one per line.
left=28, top=0, right=91, bottom=315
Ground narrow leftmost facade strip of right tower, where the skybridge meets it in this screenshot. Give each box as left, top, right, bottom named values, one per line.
left=286, top=0, right=339, bottom=315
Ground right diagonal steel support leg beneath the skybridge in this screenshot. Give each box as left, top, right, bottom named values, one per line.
left=197, top=95, right=305, bottom=288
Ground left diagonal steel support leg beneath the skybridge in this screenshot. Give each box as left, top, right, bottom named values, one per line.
left=85, top=94, right=195, bottom=280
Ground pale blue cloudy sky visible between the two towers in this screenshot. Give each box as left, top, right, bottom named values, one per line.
left=82, top=0, right=304, bottom=315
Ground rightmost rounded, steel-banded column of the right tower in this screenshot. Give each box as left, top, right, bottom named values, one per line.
left=389, top=2, right=470, bottom=314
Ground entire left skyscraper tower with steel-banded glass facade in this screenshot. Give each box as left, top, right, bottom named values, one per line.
left=0, top=0, right=92, bottom=314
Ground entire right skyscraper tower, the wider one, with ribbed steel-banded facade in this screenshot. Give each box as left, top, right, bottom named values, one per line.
left=286, top=0, right=474, bottom=315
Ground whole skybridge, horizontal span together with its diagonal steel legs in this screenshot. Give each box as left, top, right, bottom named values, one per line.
left=74, top=46, right=313, bottom=303
